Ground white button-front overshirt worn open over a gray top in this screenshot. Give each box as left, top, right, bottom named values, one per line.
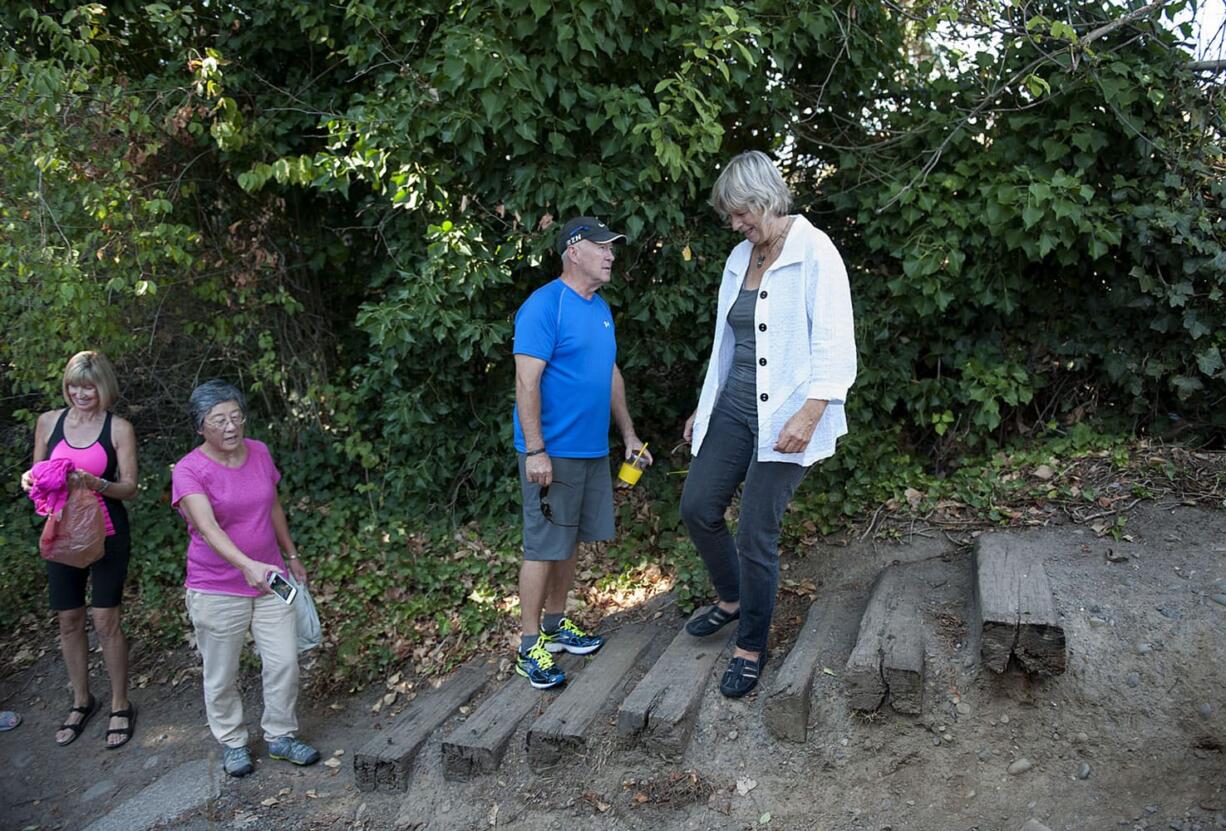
left=693, top=216, right=856, bottom=466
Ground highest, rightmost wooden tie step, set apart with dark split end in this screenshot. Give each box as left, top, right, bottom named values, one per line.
left=975, top=533, right=1067, bottom=675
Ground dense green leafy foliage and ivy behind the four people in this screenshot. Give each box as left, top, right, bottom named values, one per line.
left=0, top=0, right=1226, bottom=681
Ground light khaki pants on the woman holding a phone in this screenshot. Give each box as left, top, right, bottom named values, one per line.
left=186, top=588, right=298, bottom=748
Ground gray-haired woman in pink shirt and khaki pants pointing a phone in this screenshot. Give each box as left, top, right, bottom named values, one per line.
left=170, top=381, right=319, bottom=776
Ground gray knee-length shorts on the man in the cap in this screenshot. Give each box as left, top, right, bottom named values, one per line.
left=517, top=453, right=613, bottom=560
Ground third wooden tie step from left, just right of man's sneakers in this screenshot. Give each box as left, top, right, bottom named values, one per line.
left=527, top=625, right=653, bottom=770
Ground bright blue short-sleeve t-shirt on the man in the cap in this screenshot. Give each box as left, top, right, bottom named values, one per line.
left=515, top=278, right=617, bottom=458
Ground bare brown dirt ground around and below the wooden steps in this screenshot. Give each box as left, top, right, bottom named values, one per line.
left=0, top=505, right=1226, bottom=831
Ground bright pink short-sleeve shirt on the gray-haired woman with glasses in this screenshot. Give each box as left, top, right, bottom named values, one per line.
left=170, top=439, right=286, bottom=597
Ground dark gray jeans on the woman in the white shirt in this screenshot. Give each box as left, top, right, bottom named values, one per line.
left=682, top=396, right=809, bottom=652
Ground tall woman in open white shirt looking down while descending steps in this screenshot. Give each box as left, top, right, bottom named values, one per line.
left=682, top=151, right=856, bottom=697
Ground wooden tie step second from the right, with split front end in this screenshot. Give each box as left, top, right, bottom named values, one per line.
left=845, top=565, right=924, bottom=713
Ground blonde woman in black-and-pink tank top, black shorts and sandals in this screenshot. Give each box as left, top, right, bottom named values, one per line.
left=21, top=352, right=136, bottom=750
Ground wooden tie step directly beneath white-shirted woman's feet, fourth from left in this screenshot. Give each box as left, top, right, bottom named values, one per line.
left=617, top=609, right=736, bottom=755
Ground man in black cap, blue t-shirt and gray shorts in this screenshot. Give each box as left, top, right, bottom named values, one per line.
left=515, top=217, right=651, bottom=689
